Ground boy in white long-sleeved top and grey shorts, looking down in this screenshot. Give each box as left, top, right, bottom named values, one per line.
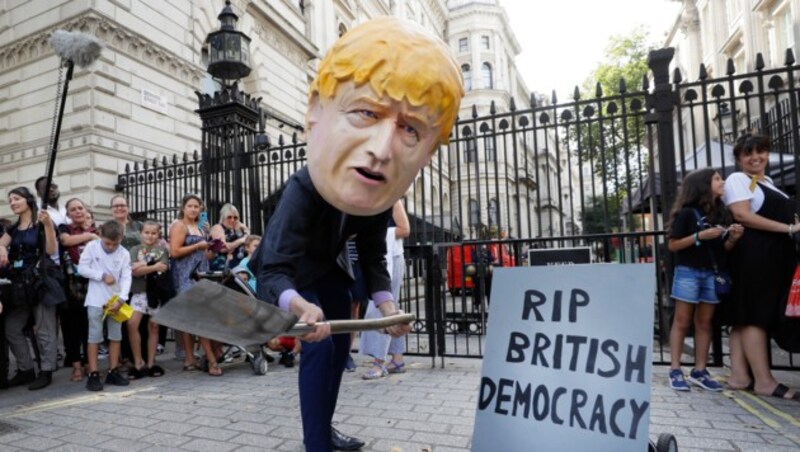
left=78, top=220, right=131, bottom=391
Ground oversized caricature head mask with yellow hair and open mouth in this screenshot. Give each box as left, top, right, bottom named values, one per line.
left=307, top=17, right=464, bottom=216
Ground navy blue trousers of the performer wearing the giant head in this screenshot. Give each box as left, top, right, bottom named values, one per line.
left=298, top=268, right=352, bottom=452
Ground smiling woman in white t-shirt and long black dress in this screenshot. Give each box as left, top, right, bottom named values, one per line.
left=723, top=134, right=800, bottom=400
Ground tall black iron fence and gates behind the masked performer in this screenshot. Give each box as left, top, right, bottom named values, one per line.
left=118, top=49, right=800, bottom=367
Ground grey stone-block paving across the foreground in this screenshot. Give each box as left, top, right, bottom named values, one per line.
left=0, top=354, right=800, bottom=452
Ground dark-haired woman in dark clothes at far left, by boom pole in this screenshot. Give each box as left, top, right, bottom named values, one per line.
left=0, top=187, right=58, bottom=390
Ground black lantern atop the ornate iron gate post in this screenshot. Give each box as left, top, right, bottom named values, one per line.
left=206, top=0, right=250, bottom=80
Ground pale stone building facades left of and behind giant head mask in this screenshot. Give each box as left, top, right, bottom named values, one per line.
left=0, top=0, right=566, bottom=235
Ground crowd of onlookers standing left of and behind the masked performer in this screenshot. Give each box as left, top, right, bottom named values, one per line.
left=0, top=177, right=410, bottom=391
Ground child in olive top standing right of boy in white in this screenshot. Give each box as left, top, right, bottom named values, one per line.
left=128, top=220, right=169, bottom=380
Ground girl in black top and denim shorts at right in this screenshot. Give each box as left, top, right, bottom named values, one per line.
left=667, top=168, right=744, bottom=391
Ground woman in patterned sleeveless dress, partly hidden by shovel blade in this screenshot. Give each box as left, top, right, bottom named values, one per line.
left=169, top=194, right=222, bottom=376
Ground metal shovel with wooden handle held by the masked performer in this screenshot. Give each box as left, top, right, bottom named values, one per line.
left=155, top=279, right=415, bottom=346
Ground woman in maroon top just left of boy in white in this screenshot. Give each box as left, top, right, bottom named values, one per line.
left=58, top=198, right=100, bottom=382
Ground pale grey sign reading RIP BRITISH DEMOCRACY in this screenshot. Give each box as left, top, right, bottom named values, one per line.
left=472, top=264, right=655, bottom=452
